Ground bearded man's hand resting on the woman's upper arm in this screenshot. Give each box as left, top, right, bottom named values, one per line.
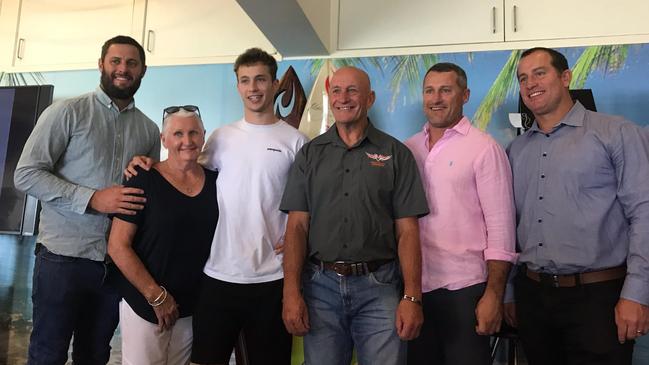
left=88, top=185, right=146, bottom=215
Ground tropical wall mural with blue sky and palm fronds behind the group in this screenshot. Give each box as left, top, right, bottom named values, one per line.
left=5, top=44, right=649, bottom=145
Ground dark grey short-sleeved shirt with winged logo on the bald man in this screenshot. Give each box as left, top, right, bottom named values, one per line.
left=280, top=124, right=428, bottom=261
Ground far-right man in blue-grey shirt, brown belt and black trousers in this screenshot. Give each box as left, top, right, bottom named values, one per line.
left=508, top=48, right=649, bottom=365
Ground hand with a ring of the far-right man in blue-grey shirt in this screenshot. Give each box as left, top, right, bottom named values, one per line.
left=615, top=298, right=649, bottom=343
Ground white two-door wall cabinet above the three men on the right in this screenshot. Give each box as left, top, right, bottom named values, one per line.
left=332, top=0, right=649, bottom=57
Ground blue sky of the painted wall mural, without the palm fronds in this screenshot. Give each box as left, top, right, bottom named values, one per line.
left=44, top=45, right=649, bottom=144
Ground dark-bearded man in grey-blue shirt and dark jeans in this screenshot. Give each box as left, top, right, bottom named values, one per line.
left=14, top=36, right=160, bottom=364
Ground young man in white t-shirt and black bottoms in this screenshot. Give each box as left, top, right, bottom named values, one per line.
left=192, top=48, right=308, bottom=365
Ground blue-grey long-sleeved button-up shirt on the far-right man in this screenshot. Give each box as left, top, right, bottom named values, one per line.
left=508, top=102, right=649, bottom=304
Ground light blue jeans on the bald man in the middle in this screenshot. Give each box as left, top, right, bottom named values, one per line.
left=302, top=261, right=406, bottom=365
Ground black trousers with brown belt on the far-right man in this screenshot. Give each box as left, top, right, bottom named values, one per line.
left=515, top=272, right=634, bottom=365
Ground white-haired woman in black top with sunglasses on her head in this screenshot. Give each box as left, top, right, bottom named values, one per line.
left=108, top=105, right=218, bottom=365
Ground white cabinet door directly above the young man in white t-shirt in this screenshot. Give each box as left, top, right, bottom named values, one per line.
left=144, top=0, right=274, bottom=65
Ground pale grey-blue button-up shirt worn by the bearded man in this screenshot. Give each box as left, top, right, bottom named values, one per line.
left=14, top=87, right=160, bottom=261
